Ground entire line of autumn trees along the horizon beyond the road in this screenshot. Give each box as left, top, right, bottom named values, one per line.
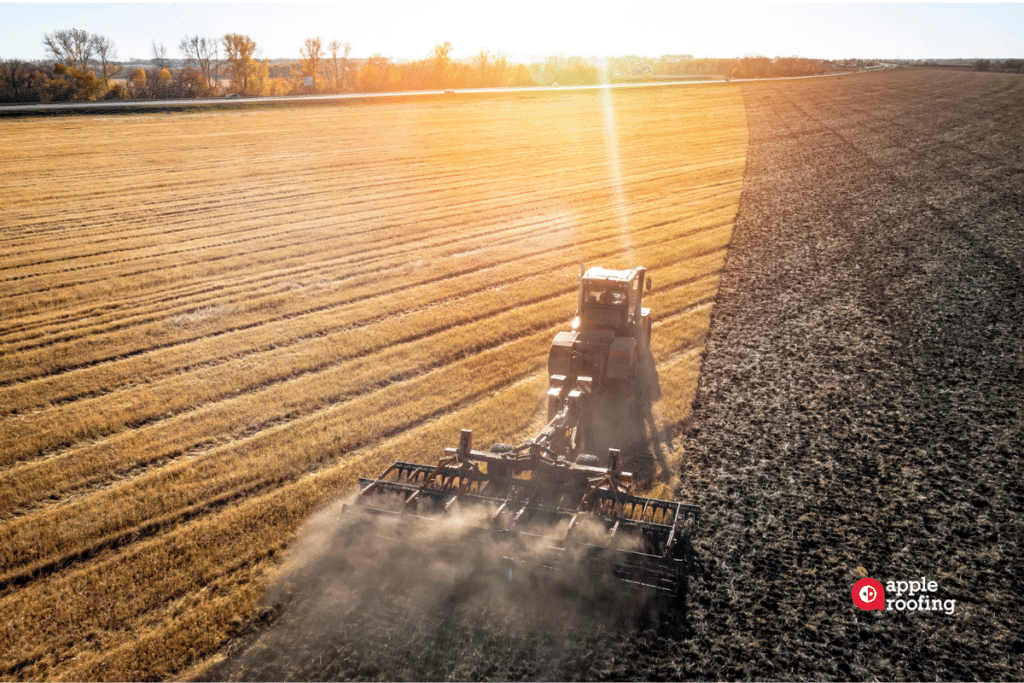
left=0, top=29, right=856, bottom=101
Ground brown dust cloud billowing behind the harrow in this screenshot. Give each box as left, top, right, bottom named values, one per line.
left=215, top=493, right=649, bottom=680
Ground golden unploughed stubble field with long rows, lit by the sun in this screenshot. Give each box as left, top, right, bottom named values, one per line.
left=0, top=86, right=746, bottom=679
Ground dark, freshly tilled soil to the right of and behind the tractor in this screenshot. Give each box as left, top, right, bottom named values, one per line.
left=206, top=72, right=1024, bottom=680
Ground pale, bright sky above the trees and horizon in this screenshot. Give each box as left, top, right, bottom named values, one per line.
left=0, top=0, right=1024, bottom=61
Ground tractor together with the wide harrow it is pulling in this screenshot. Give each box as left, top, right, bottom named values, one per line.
left=346, top=266, right=700, bottom=598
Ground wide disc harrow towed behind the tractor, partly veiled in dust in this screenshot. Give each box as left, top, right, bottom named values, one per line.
left=353, top=423, right=699, bottom=593
